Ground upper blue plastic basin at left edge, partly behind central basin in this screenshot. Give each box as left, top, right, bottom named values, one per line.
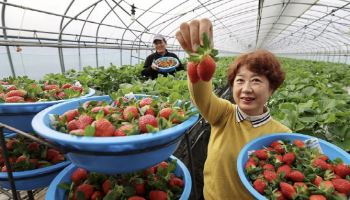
left=0, top=89, right=95, bottom=133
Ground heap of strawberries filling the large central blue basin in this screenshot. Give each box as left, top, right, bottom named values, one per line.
left=52, top=97, right=195, bottom=137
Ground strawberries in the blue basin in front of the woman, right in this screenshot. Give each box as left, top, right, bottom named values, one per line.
left=245, top=140, right=350, bottom=200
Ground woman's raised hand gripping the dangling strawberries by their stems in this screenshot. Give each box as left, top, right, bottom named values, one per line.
left=176, top=18, right=213, bottom=53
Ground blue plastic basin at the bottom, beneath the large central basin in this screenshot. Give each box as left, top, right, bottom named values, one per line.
left=45, top=156, right=192, bottom=200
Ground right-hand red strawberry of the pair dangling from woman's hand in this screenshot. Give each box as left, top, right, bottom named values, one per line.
left=197, top=55, right=216, bottom=81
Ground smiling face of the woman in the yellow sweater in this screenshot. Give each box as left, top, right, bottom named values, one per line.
left=233, top=66, right=273, bottom=116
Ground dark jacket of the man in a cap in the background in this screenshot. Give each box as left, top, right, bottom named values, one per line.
left=141, top=50, right=184, bottom=79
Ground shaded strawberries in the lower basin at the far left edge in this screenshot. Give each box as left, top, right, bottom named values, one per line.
left=0, top=137, right=65, bottom=172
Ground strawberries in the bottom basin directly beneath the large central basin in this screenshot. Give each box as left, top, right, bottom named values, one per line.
left=59, top=160, right=184, bottom=200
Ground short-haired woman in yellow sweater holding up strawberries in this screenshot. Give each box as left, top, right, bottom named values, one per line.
left=176, top=19, right=291, bottom=200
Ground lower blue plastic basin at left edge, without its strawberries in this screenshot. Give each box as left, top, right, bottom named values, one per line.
left=0, top=161, right=70, bottom=190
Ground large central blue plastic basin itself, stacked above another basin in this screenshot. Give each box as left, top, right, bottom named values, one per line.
left=32, top=95, right=198, bottom=174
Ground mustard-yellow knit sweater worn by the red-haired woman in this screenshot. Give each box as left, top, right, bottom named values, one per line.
left=188, top=81, right=291, bottom=200
